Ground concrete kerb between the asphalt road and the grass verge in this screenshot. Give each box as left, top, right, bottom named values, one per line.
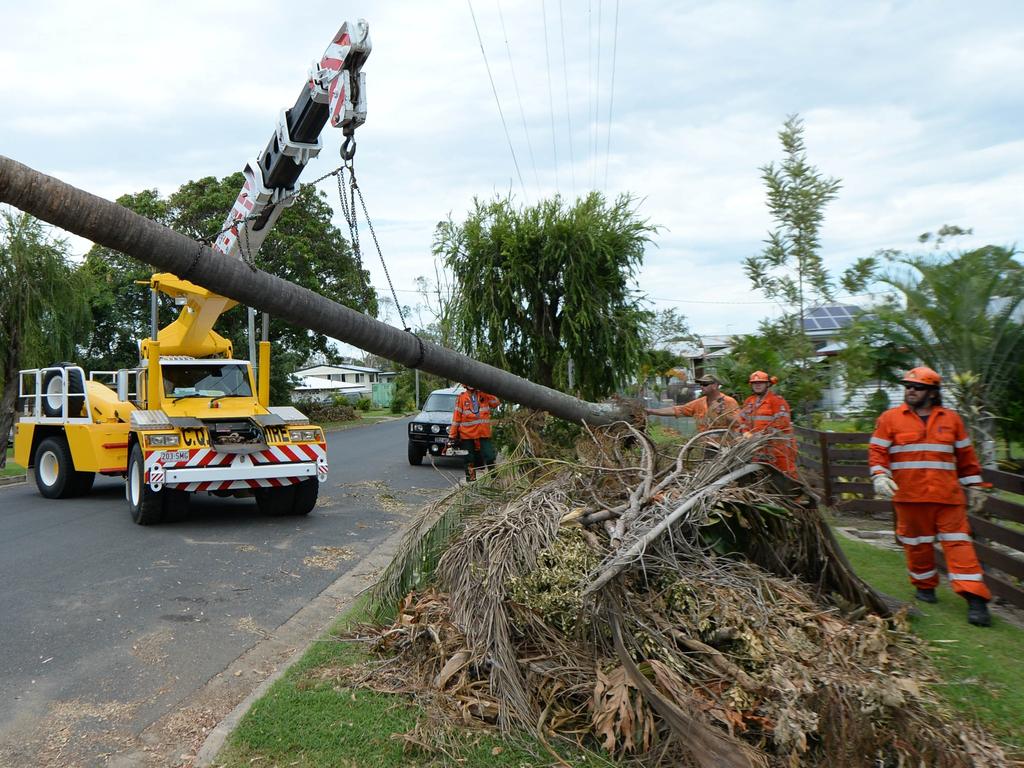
left=193, top=526, right=407, bottom=768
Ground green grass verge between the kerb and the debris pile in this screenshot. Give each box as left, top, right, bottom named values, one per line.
left=214, top=602, right=607, bottom=768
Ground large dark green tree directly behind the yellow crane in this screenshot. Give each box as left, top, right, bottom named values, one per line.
left=77, top=173, right=378, bottom=402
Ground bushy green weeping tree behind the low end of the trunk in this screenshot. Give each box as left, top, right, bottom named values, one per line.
left=434, top=193, right=654, bottom=399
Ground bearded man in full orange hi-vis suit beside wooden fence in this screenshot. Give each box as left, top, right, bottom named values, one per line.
left=867, top=367, right=992, bottom=627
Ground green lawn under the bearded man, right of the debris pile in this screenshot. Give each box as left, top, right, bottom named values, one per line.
left=838, top=537, right=1024, bottom=757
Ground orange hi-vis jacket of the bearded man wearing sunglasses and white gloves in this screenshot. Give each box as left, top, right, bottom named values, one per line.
left=867, top=403, right=987, bottom=504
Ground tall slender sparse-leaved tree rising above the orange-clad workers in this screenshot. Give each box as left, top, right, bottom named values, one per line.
left=743, top=115, right=876, bottom=416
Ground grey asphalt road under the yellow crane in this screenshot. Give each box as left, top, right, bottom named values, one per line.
left=0, top=419, right=461, bottom=766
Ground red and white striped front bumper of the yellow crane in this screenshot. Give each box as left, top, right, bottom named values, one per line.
left=145, top=442, right=328, bottom=493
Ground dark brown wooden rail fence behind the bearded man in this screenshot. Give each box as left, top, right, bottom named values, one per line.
left=796, top=427, right=1024, bottom=608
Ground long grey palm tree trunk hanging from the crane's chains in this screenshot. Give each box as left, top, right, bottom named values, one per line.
left=0, top=155, right=623, bottom=425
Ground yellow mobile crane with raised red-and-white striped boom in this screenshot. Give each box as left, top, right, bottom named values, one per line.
left=14, top=19, right=372, bottom=525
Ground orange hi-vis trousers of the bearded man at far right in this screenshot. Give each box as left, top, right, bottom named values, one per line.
left=893, top=502, right=992, bottom=600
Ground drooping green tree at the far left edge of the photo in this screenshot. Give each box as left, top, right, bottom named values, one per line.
left=0, top=210, right=88, bottom=467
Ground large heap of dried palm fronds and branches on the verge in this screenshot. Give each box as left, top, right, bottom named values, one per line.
left=364, top=417, right=1005, bottom=768
